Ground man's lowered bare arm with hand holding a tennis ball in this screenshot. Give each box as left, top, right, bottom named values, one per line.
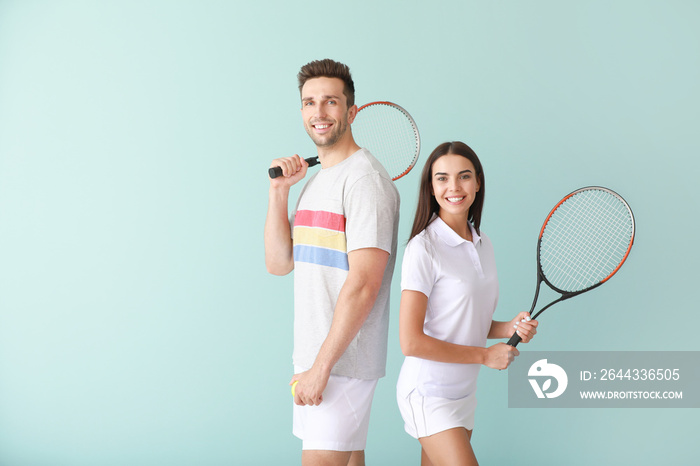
left=290, top=248, right=389, bottom=405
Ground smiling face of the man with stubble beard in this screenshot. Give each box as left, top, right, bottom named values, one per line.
left=301, top=77, right=357, bottom=147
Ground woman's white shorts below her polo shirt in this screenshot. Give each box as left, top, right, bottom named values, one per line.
left=396, top=390, right=476, bottom=439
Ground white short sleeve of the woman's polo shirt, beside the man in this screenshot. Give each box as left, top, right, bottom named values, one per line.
left=401, top=236, right=437, bottom=297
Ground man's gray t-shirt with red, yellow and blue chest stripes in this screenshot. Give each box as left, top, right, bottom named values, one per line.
left=290, top=149, right=400, bottom=379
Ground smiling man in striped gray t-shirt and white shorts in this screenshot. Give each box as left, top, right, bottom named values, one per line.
left=265, top=59, right=400, bottom=466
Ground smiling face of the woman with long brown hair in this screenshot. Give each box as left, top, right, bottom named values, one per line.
left=432, top=154, right=480, bottom=217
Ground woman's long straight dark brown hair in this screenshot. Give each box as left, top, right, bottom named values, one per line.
left=409, top=141, right=486, bottom=241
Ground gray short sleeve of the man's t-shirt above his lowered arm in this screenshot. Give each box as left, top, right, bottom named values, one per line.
left=344, top=173, right=399, bottom=254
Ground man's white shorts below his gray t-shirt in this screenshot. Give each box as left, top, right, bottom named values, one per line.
left=293, top=370, right=377, bottom=451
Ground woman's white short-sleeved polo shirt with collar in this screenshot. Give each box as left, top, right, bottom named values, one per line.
left=397, top=217, right=498, bottom=399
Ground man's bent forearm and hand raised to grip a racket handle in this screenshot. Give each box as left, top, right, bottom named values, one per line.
left=265, top=155, right=309, bottom=275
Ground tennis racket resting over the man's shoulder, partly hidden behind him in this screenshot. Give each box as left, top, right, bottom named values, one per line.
left=268, top=102, right=420, bottom=181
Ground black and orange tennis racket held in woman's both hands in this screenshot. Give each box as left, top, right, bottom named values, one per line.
left=508, top=186, right=634, bottom=346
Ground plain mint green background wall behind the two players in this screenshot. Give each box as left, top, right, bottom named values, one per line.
left=0, top=0, right=700, bottom=466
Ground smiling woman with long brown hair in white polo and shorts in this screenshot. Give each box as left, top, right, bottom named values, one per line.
left=397, top=142, right=537, bottom=466
